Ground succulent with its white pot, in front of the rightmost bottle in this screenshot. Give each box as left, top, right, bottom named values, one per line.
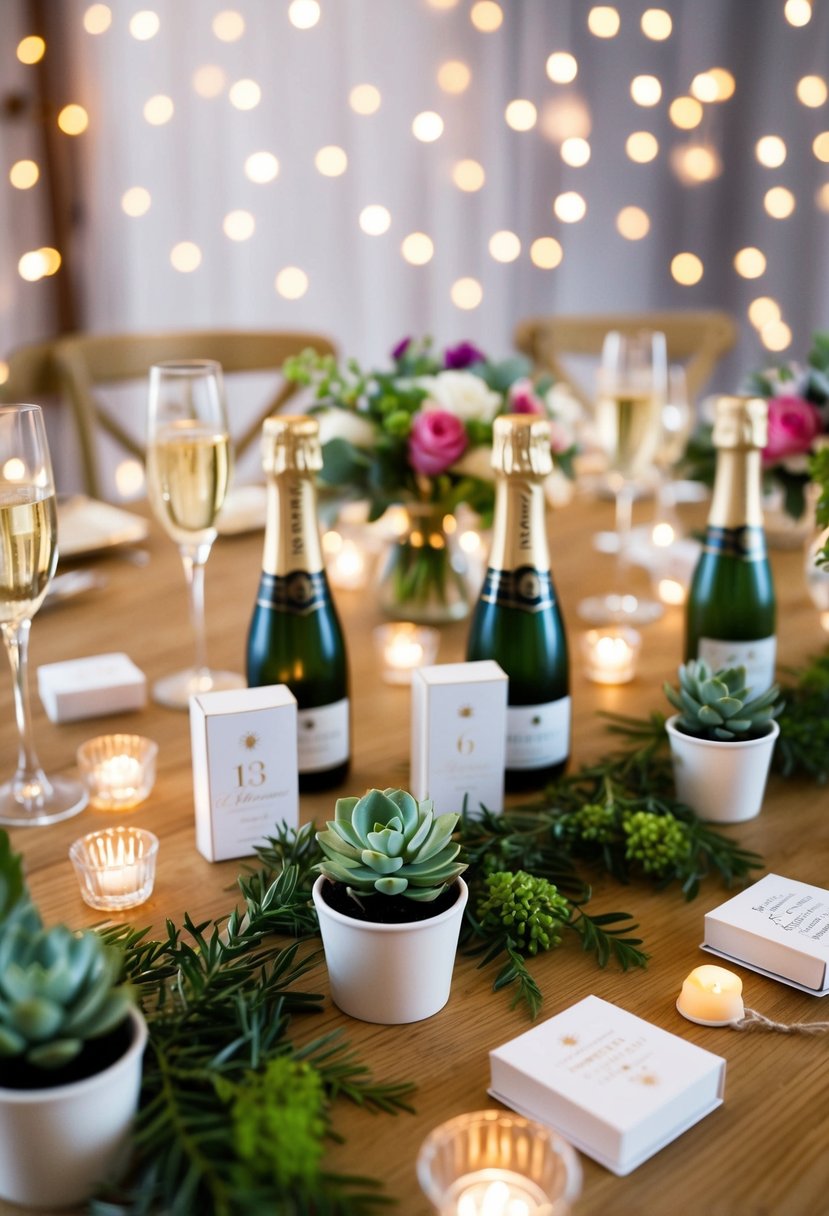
left=665, top=659, right=783, bottom=823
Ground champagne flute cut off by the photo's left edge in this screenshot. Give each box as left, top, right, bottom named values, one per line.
left=0, top=405, right=88, bottom=826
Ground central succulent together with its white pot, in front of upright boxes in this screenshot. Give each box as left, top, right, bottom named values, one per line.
left=314, top=789, right=469, bottom=1025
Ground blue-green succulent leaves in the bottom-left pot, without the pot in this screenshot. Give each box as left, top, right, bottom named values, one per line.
left=0, top=833, right=132, bottom=1070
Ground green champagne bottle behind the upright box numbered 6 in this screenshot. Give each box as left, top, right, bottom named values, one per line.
left=467, top=413, right=570, bottom=789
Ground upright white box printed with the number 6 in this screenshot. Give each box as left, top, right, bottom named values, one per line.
left=411, top=659, right=508, bottom=815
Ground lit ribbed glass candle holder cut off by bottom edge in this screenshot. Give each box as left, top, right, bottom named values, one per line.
left=417, top=1110, right=581, bottom=1216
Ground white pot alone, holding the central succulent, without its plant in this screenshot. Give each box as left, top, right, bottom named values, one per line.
left=314, top=874, right=469, bottom=1025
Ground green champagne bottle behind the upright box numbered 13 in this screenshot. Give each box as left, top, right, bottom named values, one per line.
left=247, top=415, right=350, bottom=790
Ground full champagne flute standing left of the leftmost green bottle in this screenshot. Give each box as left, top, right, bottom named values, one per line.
left=147, top=359, right=244, bottom=709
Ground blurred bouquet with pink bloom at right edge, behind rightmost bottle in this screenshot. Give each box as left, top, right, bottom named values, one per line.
left=684, top=331, right=829, bottom=518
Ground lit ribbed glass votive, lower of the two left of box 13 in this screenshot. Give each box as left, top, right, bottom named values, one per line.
left=69, top=827, right=158, bottom=912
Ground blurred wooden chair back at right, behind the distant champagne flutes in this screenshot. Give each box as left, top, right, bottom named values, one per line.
left=514, top=311, right=738, bottom=410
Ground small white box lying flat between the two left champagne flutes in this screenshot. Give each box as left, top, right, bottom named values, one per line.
left=38, top=653, right=147, bottom=722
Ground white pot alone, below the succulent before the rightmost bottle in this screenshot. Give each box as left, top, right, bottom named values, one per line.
left=665, top=714, right=780, bottom=823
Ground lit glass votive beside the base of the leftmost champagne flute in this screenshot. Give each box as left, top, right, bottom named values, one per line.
left=78, top=734, right=158, bottom=811
